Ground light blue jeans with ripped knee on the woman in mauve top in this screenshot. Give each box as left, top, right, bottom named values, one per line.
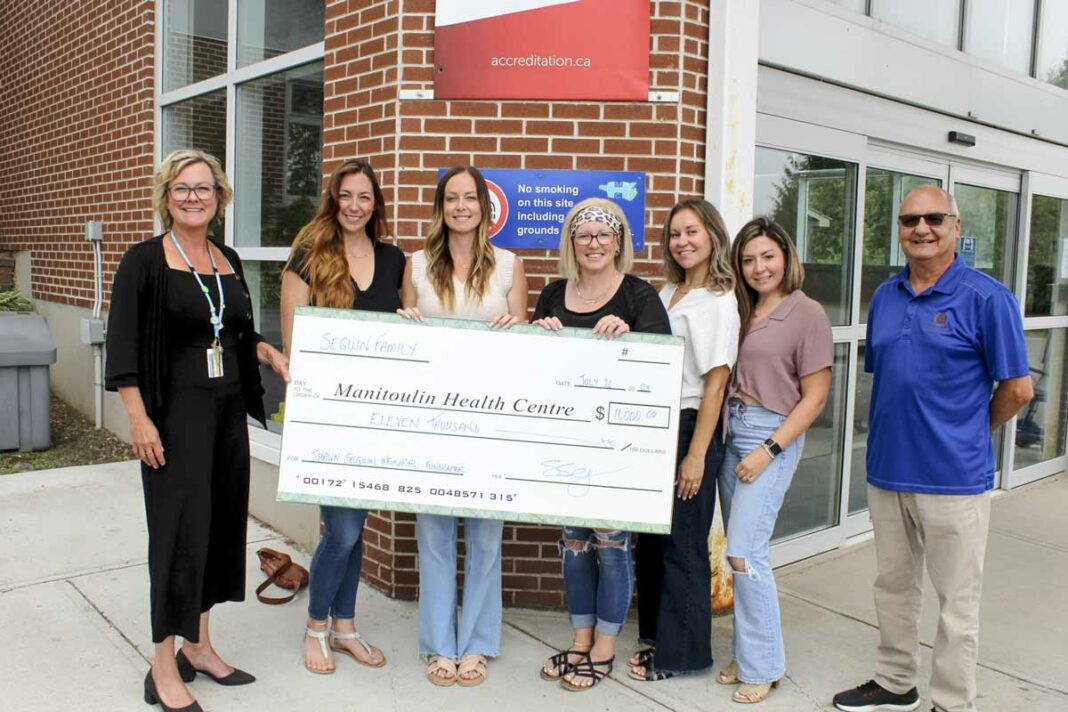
left=720, top=402, right=804, bottom=684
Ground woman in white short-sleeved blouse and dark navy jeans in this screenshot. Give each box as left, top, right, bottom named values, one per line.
left=629, top=197, right=738, bottom=681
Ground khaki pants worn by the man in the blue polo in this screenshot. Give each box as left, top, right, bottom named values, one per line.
left=868, top=485, right=990, bottom=712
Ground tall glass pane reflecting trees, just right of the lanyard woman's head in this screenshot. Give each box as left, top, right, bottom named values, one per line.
left=234, top=62, right=323, bottom=248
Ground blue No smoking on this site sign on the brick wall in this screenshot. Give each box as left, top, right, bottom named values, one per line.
left=438, top=169, right=645, bottom=251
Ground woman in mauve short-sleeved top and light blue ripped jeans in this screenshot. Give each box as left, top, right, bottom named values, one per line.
left=717, top=218, right=834, bottom=702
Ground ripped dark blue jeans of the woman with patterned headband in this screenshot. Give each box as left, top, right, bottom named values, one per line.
left=561, top=526, right=634, bottom=635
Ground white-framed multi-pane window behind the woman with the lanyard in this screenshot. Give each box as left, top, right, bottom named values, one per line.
left=158, top=0, right=325, bottom=431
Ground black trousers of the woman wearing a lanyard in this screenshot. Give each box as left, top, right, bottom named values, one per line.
left=141, top=349, right=249, bottom=643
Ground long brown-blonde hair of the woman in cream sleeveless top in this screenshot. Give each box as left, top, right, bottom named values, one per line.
left=423, top=165, right=497, bottom=310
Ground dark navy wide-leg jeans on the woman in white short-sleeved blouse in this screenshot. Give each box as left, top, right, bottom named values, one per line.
left=634, top=409, right=724, bottom=673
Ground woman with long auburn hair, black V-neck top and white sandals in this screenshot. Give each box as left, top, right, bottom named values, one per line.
left=282, top=159, right=405, bottom=675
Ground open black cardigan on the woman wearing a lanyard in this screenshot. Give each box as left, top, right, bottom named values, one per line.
left=104, top=235, right=266, bottom=427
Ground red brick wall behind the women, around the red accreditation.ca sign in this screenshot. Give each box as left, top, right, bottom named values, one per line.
left=323, top=0, right=709, bottom=607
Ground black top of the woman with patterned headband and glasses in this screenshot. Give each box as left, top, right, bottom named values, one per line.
left=533, top=274, right=671, bottom=334
